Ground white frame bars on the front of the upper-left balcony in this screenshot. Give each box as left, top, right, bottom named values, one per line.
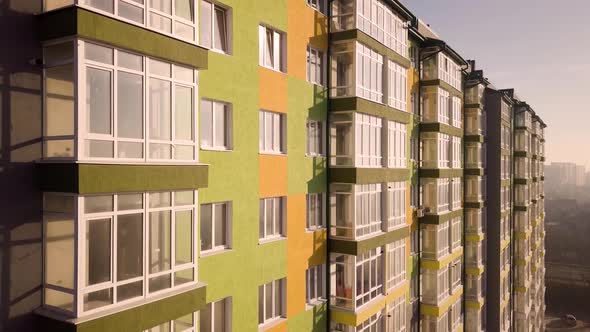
left=74, top=40, right=199, bottom=163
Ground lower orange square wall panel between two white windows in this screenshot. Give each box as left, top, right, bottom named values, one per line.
left=258, top=154, right=287, bottom=198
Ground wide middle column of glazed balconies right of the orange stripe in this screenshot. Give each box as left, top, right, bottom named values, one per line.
left=329, top=0, right=413, bottom=331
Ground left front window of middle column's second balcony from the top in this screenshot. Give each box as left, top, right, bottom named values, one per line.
left=355, top=42, right=383, bottom=103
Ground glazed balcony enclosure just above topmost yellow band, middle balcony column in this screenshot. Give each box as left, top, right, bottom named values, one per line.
left=330, top=247, right=384, bottom=311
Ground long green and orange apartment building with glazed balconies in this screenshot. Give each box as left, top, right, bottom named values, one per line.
left=0, top=0, right=545, bottom=332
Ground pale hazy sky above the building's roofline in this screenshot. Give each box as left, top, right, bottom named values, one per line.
left=402, top=0, right=590, bottom=166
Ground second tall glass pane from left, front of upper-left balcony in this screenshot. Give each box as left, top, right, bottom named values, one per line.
left=117, top=72, right=143, bottom=138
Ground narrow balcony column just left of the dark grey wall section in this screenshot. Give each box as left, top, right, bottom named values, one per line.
left=464, top=81, right=486, bottom=331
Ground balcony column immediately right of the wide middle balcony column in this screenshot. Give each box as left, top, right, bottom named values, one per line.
left=420, top=51, right=464, bottom=331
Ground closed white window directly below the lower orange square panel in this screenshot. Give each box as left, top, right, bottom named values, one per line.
left=259, top=197, right=286, bottom=240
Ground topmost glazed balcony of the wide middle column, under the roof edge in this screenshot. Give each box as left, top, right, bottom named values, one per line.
left=331, top=0, right=408, bottom=58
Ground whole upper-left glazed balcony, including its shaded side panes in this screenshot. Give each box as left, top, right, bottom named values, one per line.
left=43, top=40, right=198, bottom=163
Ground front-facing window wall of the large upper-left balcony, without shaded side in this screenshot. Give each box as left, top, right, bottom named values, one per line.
left=71, top=41, right=197, bottom=161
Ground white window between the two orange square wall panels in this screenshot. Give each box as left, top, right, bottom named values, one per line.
left=258, top=111, right=287, bottom=154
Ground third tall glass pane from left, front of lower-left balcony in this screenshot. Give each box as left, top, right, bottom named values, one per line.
left=149, top=211, right=171, bottom=274
